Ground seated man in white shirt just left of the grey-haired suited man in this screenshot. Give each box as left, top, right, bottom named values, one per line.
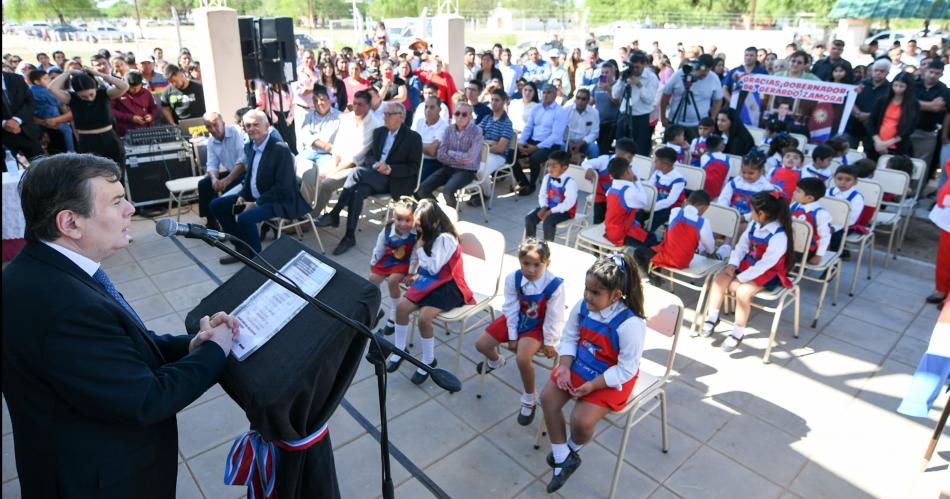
left=313, top=90, right=380, bottom=217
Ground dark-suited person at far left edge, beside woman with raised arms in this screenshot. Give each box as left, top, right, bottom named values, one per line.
left=0, top=73, right=43, bottom=159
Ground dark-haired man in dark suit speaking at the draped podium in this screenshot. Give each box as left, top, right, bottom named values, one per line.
left=2, top=154, right=238, bottom=499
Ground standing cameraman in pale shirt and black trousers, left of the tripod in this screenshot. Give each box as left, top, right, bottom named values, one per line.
left=601, top=50, right=660, bottom=156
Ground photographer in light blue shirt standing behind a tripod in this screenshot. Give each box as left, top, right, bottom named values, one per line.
left=660, top=54, right=722, bottom=141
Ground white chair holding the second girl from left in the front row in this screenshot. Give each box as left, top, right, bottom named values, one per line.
left=408, top=221, right=505, bottom=374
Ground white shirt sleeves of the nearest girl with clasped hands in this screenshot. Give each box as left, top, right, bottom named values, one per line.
left=557, top=299, right=647, bottom=390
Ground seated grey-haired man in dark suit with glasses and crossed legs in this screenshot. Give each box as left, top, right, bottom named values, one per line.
left=317, top=102, right=422, bottom=255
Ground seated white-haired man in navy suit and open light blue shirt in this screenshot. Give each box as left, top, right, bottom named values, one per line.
left=211, top=109, right=310, bottom=265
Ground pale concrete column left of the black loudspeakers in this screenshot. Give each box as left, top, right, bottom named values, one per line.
left=192, top=7, right=247, bottom=121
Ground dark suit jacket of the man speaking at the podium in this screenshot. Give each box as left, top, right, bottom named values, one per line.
left=2, top=243, right=226, bottom=499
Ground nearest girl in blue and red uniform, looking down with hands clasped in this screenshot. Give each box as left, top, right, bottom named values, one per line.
left=541, top=254, right=646, bottom=494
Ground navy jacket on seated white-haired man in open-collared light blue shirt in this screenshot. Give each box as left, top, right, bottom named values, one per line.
left=241, top=133, right=310, bottom=218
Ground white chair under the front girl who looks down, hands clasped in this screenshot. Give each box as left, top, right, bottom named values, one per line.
left=534, top=284, right=683, bottom=499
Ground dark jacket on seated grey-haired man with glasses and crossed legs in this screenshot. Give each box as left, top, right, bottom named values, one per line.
left=363, top=123, right=422, bottom=199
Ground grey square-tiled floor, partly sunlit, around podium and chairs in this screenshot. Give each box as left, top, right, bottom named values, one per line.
left=2, top=190, right=950, bottom=499
